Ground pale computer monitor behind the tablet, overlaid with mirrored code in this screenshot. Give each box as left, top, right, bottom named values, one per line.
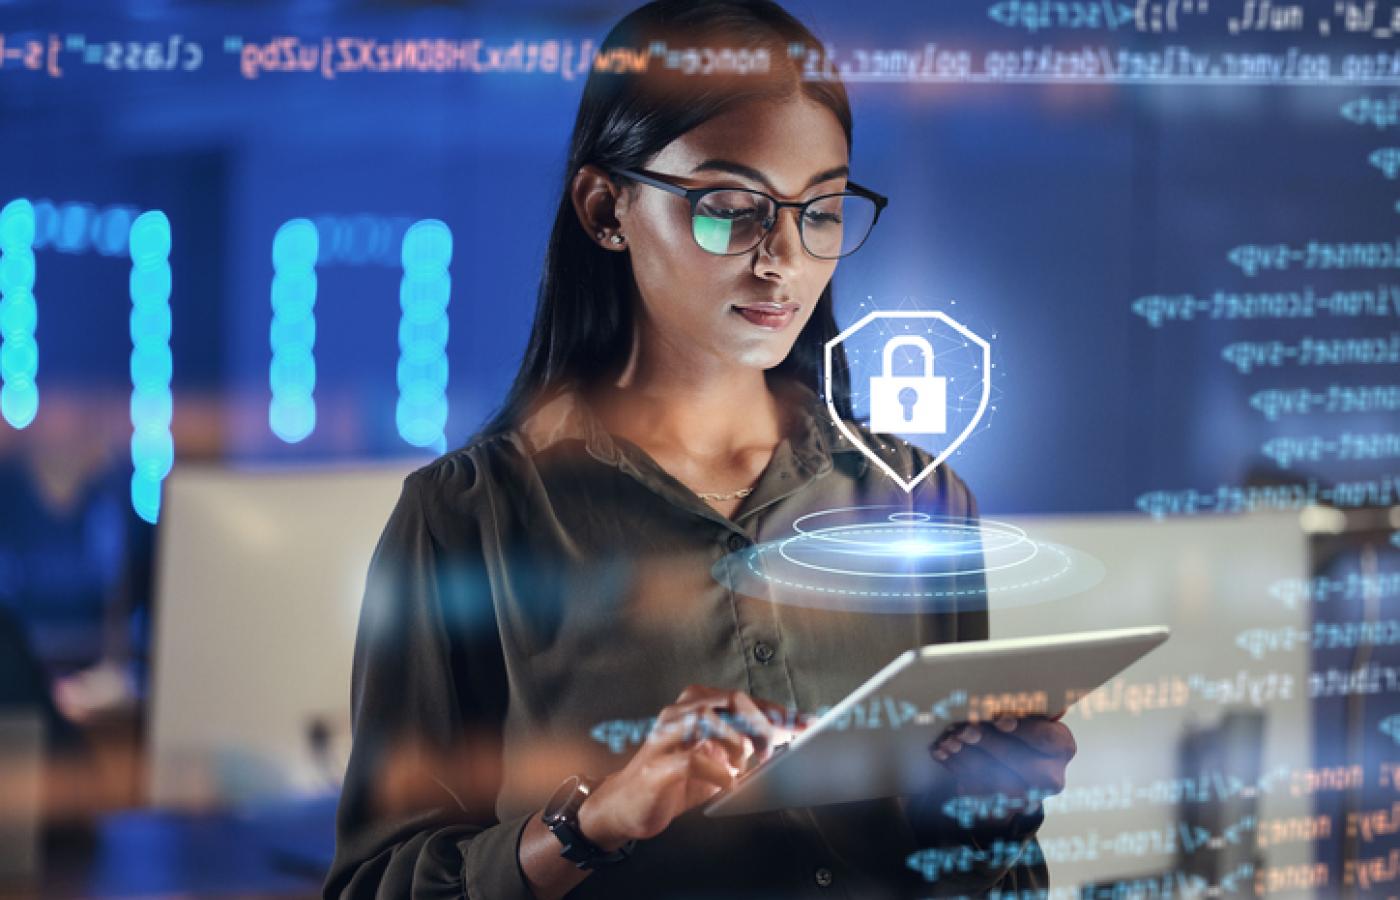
left=988, top=509, right=1329, bottom=896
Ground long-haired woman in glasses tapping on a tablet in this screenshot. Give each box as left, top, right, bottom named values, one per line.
left=325, top=0, right=1074, bottom=900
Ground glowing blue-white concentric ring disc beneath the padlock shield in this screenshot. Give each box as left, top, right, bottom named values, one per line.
left=713, top=507, right=1103, bottom=613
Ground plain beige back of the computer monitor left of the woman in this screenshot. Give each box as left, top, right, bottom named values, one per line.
left=150, top=462, right=421, bottom=809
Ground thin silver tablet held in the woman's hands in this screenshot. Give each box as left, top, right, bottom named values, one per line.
left=704, top=627, right=1169, bottom=816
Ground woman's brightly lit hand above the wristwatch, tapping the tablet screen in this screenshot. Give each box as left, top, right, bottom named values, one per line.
left=578, top=684, right=795, bottom=851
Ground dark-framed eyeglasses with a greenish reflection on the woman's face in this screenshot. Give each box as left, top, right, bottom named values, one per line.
left=608, top=168, right=889, bottom=259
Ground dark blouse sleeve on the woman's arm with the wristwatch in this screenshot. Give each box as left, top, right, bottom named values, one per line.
left=322, top=451, right=532, bottom=900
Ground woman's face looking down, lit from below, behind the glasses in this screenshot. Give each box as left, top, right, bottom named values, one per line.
left=616, top=98, right=848, bottom=370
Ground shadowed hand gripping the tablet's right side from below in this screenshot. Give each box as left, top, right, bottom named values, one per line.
left=930, top=715, right=1078, bottom=826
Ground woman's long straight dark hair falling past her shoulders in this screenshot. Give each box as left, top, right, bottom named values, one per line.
left=483, top=0, right=853, bottom=434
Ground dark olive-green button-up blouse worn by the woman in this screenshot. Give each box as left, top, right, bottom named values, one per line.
left=323, top=386, right=1047, bottom=900
